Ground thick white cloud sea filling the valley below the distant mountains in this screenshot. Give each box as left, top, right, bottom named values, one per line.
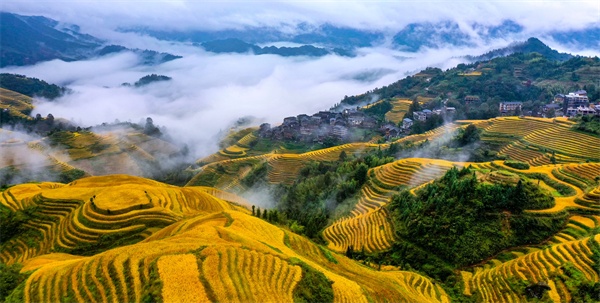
left=2, top=43, right=492, bottom=157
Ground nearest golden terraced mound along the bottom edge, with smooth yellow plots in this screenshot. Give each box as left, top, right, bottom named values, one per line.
left=15, top=211, right=448, bottom=303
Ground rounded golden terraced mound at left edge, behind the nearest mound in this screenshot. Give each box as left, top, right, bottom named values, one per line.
left=0, top=175, right=247, bottom=263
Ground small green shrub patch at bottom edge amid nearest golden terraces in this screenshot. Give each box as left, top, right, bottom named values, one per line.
left=290, top=258, right=333, bottom=303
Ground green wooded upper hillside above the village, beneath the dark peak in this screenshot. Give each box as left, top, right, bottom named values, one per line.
left=339, top=53, right=600, bottom=122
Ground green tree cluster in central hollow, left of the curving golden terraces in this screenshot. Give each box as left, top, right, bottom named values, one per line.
left=242, top=151, right=398, bottom=243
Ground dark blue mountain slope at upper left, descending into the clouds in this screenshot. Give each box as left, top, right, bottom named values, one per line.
left=0, top=12, right=181, bottom=67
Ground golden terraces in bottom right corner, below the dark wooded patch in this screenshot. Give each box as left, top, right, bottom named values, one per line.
left=463, top=235, right=600, bottom=302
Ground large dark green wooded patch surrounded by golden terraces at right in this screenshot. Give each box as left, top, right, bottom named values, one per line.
left=388, top=168, right=567, bottom=280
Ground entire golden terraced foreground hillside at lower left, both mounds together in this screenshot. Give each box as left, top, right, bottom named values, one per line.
left=2, top=176, right=448, bottom=302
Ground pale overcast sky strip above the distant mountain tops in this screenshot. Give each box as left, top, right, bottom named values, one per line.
left=0, top=0, right=600, bottom=33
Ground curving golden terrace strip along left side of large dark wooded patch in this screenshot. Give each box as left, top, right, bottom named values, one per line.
left=323, top=158, right=452, bottom=252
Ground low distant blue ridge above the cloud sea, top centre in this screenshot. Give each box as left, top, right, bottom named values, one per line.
left=201, top=38, right=352, bottom=57
